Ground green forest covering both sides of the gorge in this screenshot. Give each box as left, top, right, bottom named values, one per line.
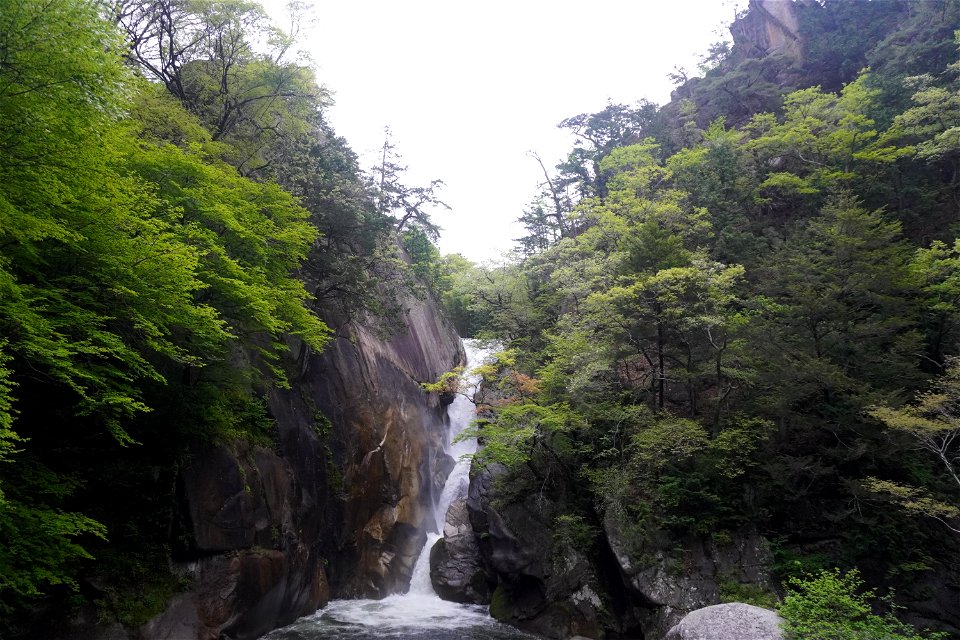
left=0, top=0, right=960, bottom=639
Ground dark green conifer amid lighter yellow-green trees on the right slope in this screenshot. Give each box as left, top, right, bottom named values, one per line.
left=752, top=194, right=920, bottom=428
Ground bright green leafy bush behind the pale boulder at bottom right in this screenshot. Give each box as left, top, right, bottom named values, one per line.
left=780, top=569, right=947, bottom=640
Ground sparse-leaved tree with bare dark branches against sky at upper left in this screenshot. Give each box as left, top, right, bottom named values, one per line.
left=115, top=0, right=329, bottom=175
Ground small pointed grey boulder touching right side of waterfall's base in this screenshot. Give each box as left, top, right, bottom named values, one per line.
left=430, top=498, right=490, bottom=604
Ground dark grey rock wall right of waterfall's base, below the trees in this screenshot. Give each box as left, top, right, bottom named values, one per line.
left=431, top=466, right=774, bottom=640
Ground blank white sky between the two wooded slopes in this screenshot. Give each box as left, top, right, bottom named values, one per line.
left=264, top=0, right=743, bottom=262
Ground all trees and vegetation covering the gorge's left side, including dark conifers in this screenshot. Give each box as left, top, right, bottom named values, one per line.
left=0, top=0, right=435, bottom=636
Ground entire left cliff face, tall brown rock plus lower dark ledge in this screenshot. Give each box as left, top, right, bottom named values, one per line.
left=141, top=300, right=463, bottom=640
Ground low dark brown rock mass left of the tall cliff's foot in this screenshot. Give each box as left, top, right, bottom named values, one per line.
left=141, top=445, right=330, bottom=640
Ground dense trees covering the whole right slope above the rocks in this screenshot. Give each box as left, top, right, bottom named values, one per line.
left=428, top=0, right=960, bottom=637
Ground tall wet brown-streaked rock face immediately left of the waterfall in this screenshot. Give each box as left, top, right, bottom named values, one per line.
left=270, top=300, right=464, bottom=598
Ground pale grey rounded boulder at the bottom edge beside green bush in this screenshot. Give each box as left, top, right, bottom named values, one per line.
left=664, top=602, right=783, bottom=640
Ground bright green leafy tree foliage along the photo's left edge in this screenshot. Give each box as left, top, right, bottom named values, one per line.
left=0, top=0, right=342, bottom=622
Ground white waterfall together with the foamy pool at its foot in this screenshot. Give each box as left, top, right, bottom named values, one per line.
left=262, top=340, right=534, bottom=640
